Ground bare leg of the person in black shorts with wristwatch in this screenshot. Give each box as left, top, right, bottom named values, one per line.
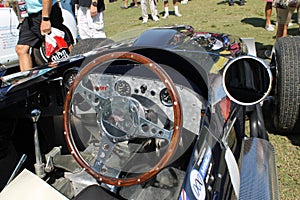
left=16, top=45, right=32, bottom=71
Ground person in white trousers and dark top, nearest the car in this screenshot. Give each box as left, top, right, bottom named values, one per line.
left=72, top=0, right=106, bottom=39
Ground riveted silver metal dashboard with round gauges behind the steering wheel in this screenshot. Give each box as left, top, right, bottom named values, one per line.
left=85, top=73, right=203, bottom=134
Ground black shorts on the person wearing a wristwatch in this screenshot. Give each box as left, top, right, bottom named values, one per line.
left=18, top=3, right=63, bottom=47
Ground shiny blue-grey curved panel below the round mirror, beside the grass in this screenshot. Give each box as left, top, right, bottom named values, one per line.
left=239, top=138, right=279, bottom=200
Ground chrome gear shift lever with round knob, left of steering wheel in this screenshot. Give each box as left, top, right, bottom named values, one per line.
left=31, top=109, right=46, bottom=178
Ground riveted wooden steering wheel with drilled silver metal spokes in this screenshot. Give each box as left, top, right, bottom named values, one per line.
left=63, top=52, right=182, bottom=186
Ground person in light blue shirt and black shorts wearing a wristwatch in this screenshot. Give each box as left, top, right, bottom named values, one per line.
left=16, top=0, right=63, bottom=71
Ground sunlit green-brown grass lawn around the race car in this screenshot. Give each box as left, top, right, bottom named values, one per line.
left=104, top=0, right=300, bottom=200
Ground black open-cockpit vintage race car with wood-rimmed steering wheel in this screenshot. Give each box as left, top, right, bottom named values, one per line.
left=0, top=25, right=300, bottom=200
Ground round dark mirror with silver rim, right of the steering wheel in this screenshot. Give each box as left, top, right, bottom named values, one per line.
left=223, top=56, right=272, bottom=105
